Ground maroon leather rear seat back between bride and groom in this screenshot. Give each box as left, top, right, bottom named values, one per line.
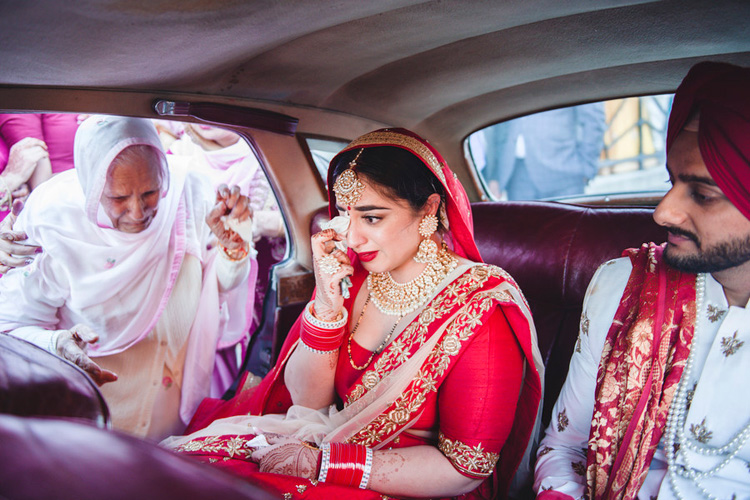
left=472, top=202, right=666, bottom=426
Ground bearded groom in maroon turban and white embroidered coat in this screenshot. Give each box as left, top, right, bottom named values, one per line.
left=534, top=62, right=750, bottom=500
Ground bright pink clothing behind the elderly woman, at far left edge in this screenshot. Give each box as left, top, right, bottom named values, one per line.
left=0, top=113, right=78, bottom=174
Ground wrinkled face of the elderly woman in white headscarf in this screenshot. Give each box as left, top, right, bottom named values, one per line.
left=101, top=149, right=161, bottom=233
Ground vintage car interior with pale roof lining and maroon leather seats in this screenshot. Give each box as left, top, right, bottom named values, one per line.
left=0, top=0, right=750, bottom=499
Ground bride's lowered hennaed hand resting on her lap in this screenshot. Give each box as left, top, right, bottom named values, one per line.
left=250, top=434, right=320, bottom=480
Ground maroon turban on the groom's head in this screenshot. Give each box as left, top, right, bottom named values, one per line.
left=667, top=62, right=750, bottom=219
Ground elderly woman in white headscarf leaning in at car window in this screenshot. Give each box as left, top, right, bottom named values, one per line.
left=0, top=116, right=253, bottom=439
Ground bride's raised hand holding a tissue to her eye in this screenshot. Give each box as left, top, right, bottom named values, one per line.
left=312, top=229, right=354, bottom=321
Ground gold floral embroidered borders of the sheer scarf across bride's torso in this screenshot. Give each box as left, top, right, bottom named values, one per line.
left=348, top=264, right=524, bottom=446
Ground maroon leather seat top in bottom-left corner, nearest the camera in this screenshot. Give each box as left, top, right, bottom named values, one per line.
left=0, top=415, right=277, bottom=500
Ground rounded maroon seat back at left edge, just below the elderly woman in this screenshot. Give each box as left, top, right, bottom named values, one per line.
left=0, top=334, right=109, bottom=427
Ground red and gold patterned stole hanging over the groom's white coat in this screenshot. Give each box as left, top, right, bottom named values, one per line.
left=586, top=243, right=695, bottom=499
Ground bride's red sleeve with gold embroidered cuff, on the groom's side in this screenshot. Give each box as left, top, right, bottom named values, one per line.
left=438, top=308, right=524, bottom=478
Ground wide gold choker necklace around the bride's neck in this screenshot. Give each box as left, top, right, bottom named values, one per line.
left=367, top=243, right=458, bottom=317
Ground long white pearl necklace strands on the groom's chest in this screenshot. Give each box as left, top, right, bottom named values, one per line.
left=665, top=274, right=750, bottom=500
